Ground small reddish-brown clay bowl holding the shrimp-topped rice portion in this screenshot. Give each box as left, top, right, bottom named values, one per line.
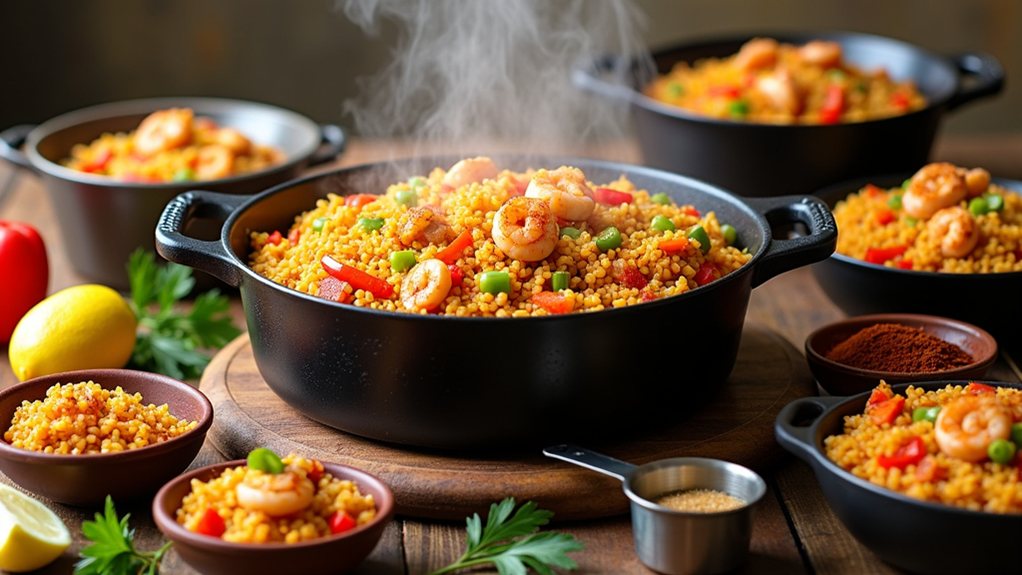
left=152, top=460, right=394, bottom=575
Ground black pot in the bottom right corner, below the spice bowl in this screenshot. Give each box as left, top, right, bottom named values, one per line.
left=775, top=381, right=1022, bottom=574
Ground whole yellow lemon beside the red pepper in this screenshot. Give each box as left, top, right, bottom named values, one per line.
left=8, top=284, right=136, bottom=381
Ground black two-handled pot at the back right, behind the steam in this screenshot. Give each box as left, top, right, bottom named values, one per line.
left=575, top=32, right=1005, bottom=196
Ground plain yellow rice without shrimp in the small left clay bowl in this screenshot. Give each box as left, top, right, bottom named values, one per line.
left=3, top=381, right=197, bottom=456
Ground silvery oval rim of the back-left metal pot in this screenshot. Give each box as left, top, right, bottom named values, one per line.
left=25, top=96, right=320, bottom=190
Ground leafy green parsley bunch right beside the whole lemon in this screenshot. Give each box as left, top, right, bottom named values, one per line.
left=128, top=249, right=241, bottom=379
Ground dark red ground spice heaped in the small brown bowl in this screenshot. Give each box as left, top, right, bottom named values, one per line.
left=826, top=324, right=973, bottom=373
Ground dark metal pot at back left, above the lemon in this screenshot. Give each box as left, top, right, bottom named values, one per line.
left=0, top=98, right=344, bottom=290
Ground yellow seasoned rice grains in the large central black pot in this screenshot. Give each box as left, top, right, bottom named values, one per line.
left=249, top=162, right=752, bottom=318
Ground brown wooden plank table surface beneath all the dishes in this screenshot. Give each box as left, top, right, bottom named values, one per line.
left=0, top=136, right=1022, bottom=575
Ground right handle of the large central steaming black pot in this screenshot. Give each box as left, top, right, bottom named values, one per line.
left=744, top=196, right=837, bottom=287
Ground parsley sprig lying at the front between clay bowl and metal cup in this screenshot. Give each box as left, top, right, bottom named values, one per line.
left=431, top=497, right=584, bottom=575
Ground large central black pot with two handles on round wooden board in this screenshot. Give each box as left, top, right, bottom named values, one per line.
left=156, top=157, right=836, bottom=448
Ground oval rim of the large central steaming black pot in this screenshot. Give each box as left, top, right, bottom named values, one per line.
left=213, top=154, right=772, bottom=323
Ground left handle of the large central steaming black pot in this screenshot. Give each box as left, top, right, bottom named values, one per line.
left=156, top=190, right=249, bottom=287
